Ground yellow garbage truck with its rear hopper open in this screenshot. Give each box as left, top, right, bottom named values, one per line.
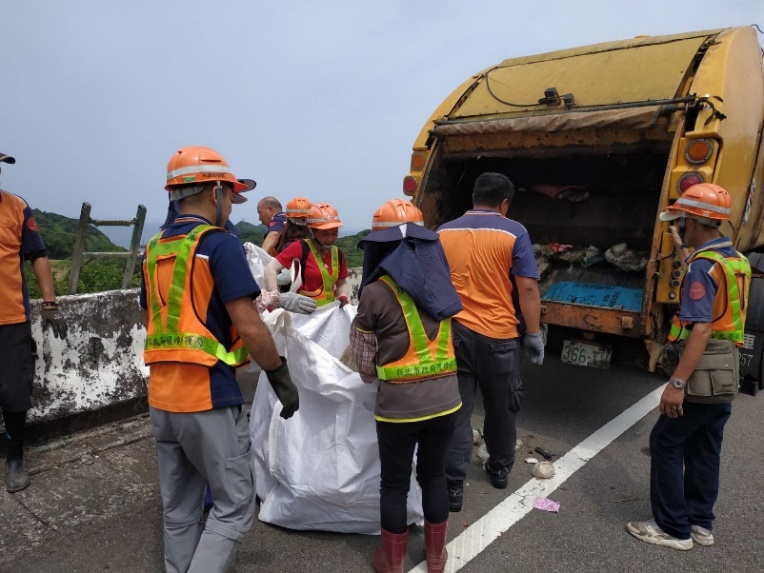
left=403, top=27, right=764, bottom=386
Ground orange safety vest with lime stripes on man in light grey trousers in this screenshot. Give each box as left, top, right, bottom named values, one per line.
left=143, top=225, right=249, bottom=367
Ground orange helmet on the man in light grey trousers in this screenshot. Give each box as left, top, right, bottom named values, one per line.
left=165, top=145, right=256, bottom=203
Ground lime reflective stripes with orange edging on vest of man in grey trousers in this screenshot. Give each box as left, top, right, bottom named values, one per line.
left=144, top=225, right=248, bottom=366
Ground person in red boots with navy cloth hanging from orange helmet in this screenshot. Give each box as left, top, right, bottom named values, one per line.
left=350, top=199, right=462, bottom=573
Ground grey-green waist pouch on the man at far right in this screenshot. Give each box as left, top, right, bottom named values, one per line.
left=662, top=339, right=740, bottom=404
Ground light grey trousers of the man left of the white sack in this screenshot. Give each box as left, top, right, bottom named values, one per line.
left=150, top=406, right=255, bottom=573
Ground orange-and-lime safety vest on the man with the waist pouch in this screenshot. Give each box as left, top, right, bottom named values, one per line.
left=669, top=250, right=751, bottom=345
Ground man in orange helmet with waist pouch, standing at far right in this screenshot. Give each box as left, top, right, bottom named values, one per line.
left=626, top=183, right=751, bottom=550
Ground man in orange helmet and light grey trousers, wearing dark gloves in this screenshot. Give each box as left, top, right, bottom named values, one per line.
left=140, top=146, right=299, bottom=573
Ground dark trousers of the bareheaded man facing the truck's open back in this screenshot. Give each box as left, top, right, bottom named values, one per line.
left=446, top=320, right=525, bottom=485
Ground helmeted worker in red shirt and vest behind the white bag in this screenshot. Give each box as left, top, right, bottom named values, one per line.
left=265, top=203, right=349, bottom=308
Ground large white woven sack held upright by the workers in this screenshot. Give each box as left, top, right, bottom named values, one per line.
left=250, top=303, right=423, bottom=534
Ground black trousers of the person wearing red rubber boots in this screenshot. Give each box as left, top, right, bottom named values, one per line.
left=377, top=413, right=456, bottom=533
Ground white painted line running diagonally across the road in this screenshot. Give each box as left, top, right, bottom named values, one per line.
left=409, top=384, right=665, bottom=573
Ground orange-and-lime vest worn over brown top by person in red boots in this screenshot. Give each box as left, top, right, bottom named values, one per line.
left=377, top=275, right=456, bottom=384
